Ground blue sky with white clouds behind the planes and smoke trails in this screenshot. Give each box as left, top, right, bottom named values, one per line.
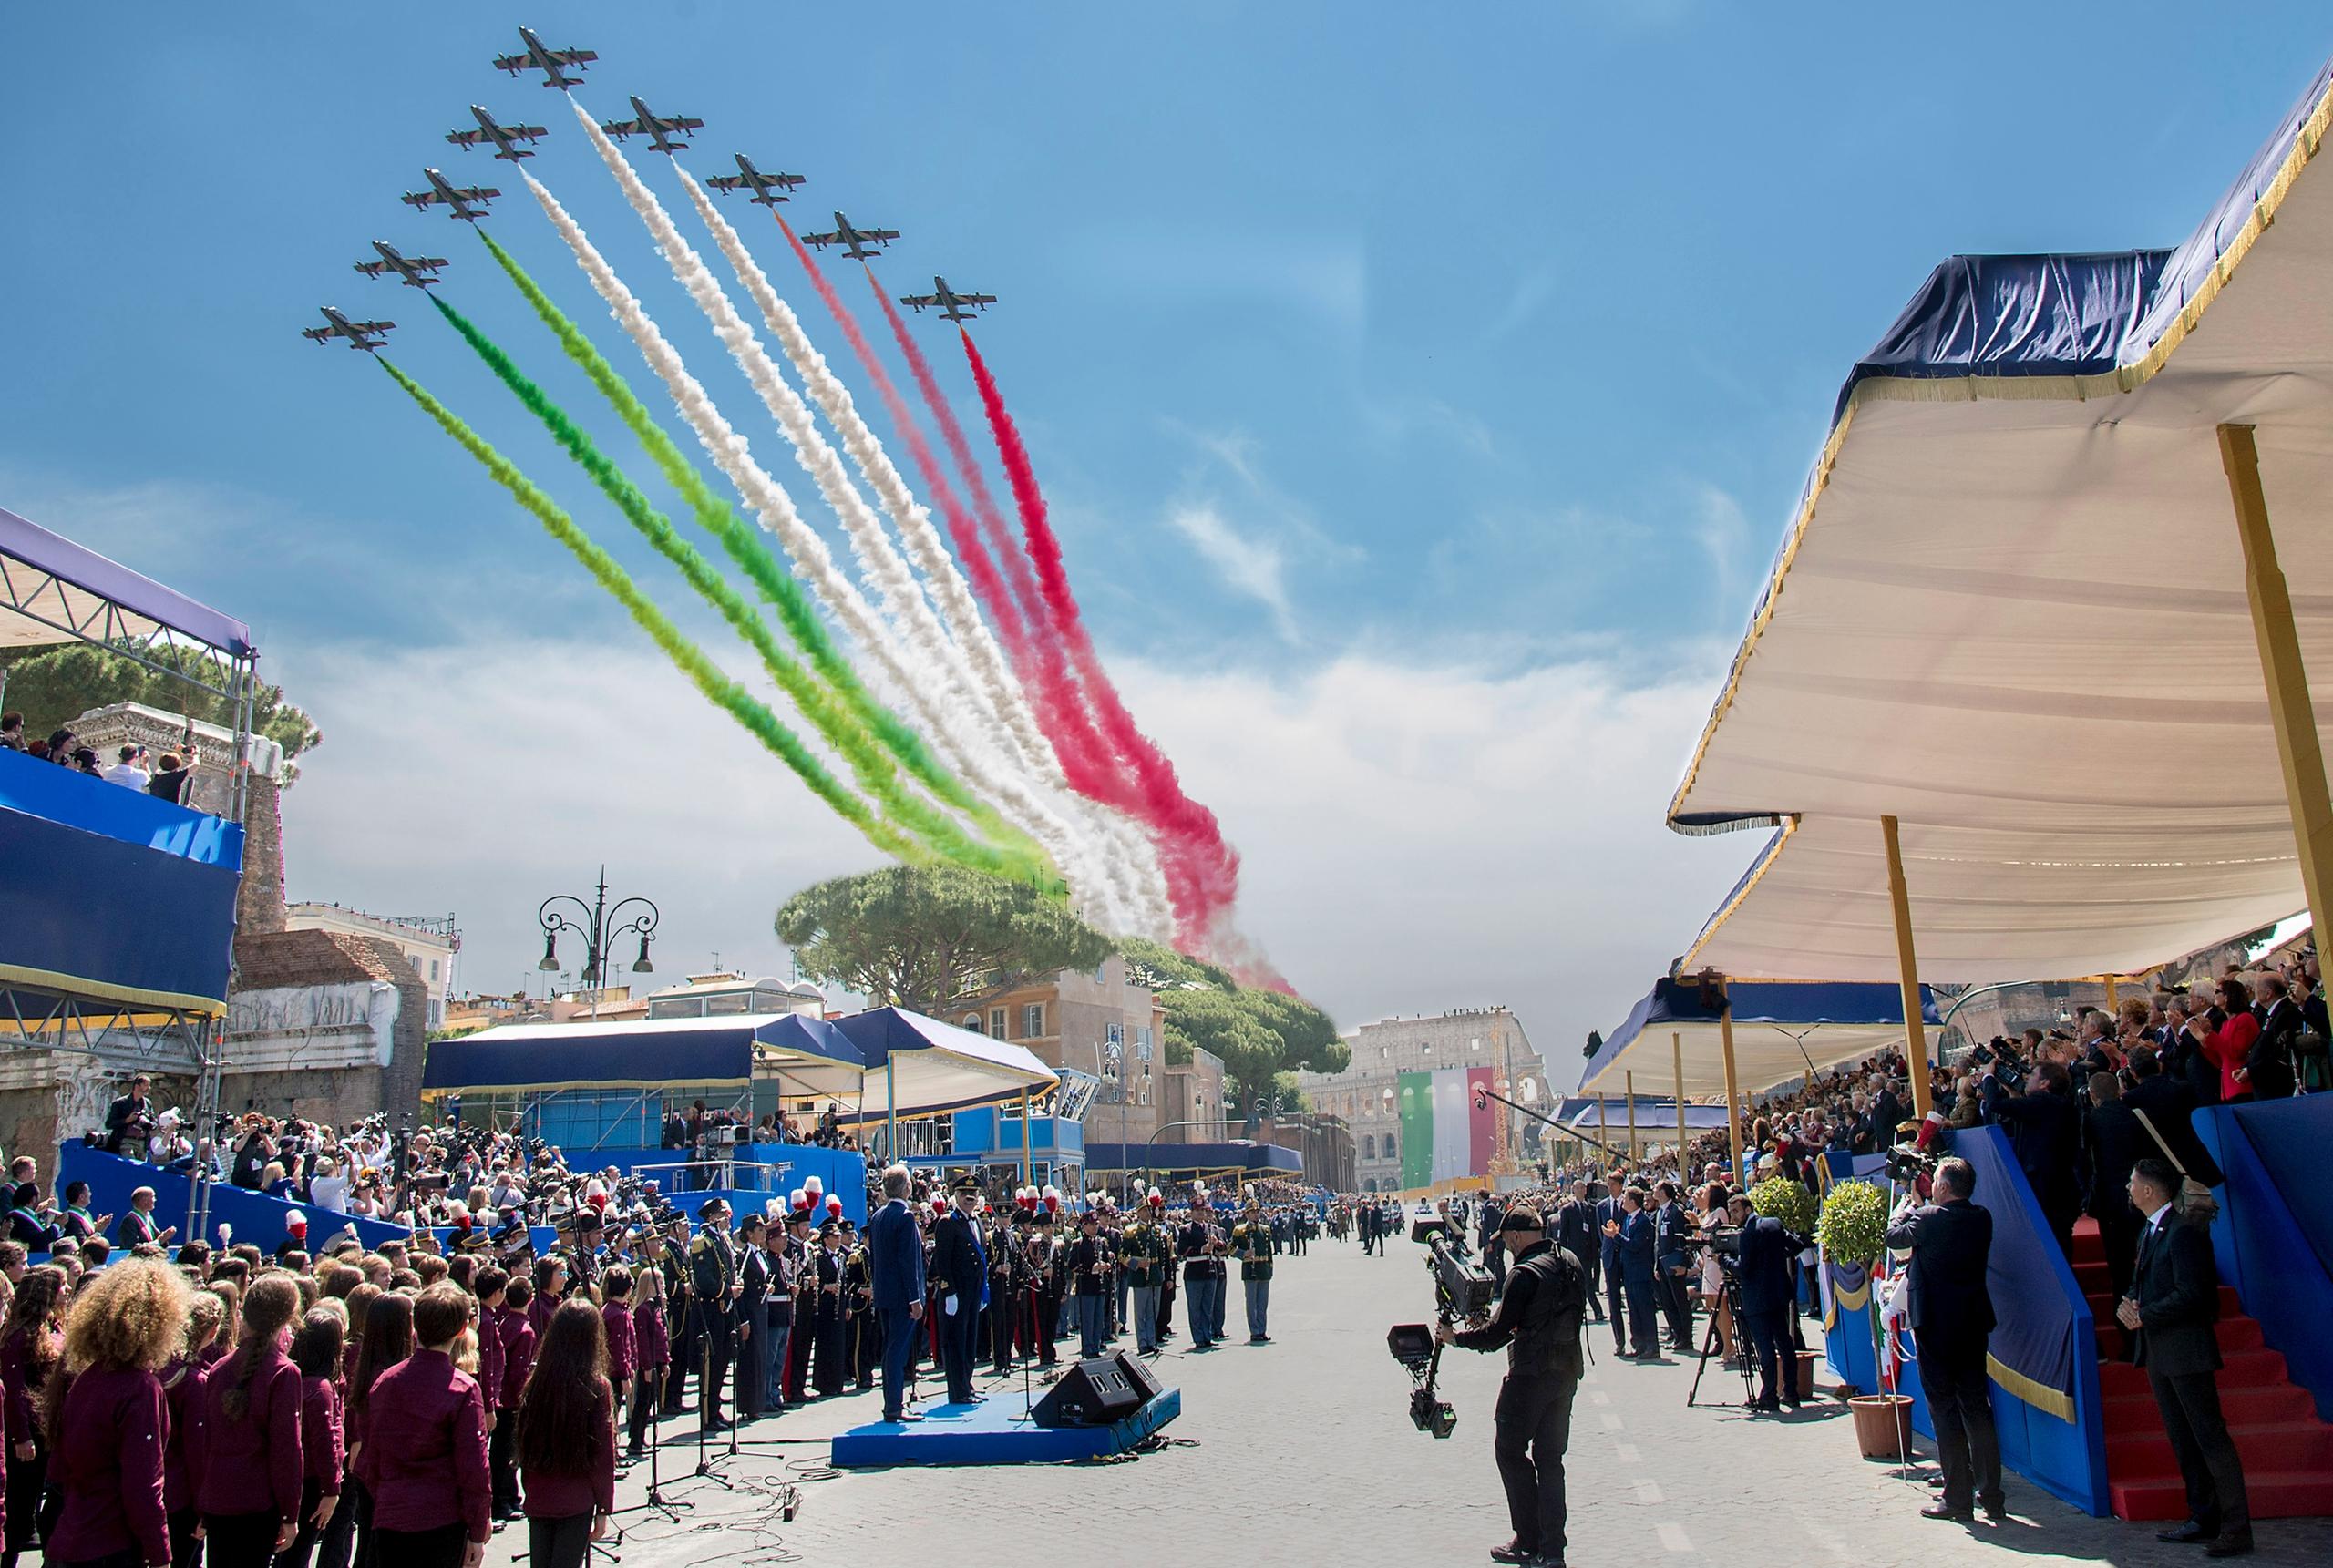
left=0, top=0, right=2333, bottom=1054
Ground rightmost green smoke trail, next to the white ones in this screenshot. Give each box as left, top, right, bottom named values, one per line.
left=478, top=229, right=1043, bottom=876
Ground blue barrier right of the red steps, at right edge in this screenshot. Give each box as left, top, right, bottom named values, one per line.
left=2193, top=1094, right=2333, bottom=1421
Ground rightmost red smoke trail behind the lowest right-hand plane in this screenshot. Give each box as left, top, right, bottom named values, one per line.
left=957, top=329, right=1238, bottom=952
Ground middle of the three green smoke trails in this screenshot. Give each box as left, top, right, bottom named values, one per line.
left=429, top=294, right=1038, bottom=875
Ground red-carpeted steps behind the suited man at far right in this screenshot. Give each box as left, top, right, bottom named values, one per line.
left=2074, top=1218, right=2333, bottom=1519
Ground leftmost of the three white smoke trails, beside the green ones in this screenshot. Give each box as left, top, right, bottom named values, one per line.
left=518, top=167, right=1126, bottom=938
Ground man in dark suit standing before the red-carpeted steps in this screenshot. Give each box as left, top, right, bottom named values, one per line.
left=2113, top=1160, right=2251, bottom=1556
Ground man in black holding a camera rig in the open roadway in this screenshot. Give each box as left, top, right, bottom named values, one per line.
left=1434, top=1204, right=1588, bottom=1568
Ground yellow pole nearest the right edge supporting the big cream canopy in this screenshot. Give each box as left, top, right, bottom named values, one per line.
left=2219, top=425, right=2333, bottom=957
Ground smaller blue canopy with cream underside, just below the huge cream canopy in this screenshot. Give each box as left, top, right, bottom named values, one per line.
left=1579, top=976, right=1938, bottom=1096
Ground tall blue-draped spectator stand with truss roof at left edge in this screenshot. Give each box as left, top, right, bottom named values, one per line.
left=0, top=508, right=259, bottom=1220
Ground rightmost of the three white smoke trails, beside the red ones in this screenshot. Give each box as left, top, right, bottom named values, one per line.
left=674, top=166, right=1174, bottom=933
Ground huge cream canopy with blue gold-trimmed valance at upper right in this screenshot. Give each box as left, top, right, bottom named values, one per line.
left=1670, top=72, right=2333, bottom=982
